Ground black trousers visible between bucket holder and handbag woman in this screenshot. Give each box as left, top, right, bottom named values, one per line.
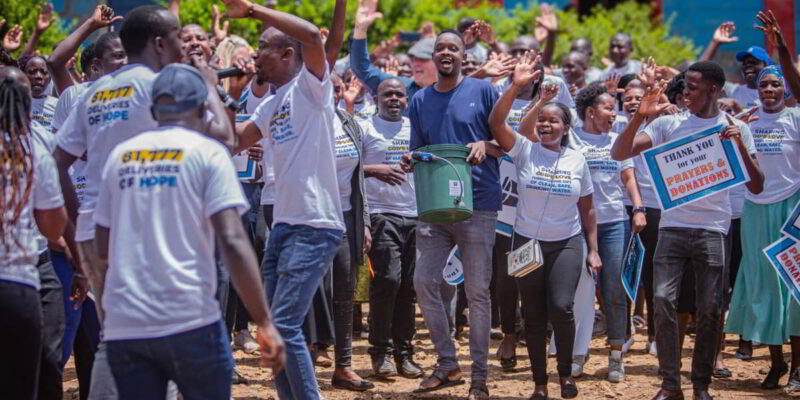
left=493, top=234, right=520, bottom=335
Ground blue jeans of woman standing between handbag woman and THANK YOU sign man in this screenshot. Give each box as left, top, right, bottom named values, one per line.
left=597, top=220, right=630, bottom=346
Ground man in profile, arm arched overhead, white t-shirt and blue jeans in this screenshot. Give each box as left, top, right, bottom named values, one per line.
left=225, top=0, right=345, bottom=400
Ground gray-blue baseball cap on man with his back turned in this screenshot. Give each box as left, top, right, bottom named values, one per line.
left=152, top=63, right=208, bottom=113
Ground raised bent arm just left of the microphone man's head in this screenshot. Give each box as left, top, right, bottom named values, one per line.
left=47, top=5, right=122, bottom=93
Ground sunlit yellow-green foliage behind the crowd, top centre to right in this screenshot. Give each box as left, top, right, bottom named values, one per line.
left=177, top=0, right=700, bottom=66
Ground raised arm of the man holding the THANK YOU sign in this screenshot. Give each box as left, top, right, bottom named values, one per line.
left=611, top=82, right=670, bottom=161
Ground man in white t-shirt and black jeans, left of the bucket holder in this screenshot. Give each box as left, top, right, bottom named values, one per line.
left=361, top=78, right=422, bottom=378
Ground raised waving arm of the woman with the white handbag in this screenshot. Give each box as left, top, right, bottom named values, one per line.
left=489, top=51, right=542, bottom=152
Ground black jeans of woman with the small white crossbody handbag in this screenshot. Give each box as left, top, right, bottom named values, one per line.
left=513, top=234, right=586, bottom=385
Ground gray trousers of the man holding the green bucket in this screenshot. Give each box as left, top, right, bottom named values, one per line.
left=414, top=211, right=497, bottom=381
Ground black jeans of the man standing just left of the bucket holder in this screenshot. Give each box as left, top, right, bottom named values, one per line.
left=368, top=214, right=417, bottom=358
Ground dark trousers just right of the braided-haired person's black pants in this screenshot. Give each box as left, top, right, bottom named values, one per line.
left=36, top=255, right=65, bottom=400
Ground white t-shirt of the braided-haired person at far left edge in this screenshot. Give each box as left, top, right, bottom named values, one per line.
left=0, top=140, right=64, bottom=290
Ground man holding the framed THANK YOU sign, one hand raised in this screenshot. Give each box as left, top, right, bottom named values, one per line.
left=611, top=61, right=764, bottom=400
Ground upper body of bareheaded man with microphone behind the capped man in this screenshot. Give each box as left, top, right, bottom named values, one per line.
left=53, top=6, right=233, bottom=314
